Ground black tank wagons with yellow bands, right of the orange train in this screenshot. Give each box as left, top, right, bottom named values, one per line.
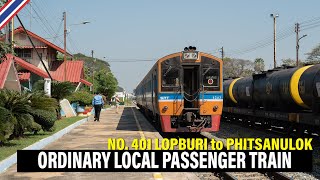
left=223, top=64, right=320, bottom=134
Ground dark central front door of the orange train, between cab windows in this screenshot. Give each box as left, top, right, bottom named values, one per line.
left=183, top=66, right=200, bottom=108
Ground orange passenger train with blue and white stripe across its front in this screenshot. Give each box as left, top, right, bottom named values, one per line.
left=134, top=46, right=223, bottom=133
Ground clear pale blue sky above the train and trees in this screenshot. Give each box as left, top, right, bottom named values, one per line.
left=16, top=0, right=320, bottom=92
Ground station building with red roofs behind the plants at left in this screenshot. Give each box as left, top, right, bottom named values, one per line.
left=0, top=27, right=92, bottom=90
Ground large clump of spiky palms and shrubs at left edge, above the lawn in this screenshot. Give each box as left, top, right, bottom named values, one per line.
left=0, top=89, right=57, bottom=143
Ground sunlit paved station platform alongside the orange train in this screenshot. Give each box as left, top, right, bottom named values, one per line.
left=0, top=106, right=199, bottom=180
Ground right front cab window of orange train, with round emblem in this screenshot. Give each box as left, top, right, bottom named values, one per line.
left=202, top=57, right=220, bottom=91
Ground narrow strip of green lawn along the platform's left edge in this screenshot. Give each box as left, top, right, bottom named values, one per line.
left=0, top=117, right=85, bottom=161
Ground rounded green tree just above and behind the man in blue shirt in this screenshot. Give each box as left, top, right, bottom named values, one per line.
left=94, top=70, right=118, bottom=98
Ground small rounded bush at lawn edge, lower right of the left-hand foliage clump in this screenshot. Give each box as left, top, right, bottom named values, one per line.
left=31, top=109, right=57, bottom=131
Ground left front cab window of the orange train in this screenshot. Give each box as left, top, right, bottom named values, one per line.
left=161, top=57, right=181, bottom=91
